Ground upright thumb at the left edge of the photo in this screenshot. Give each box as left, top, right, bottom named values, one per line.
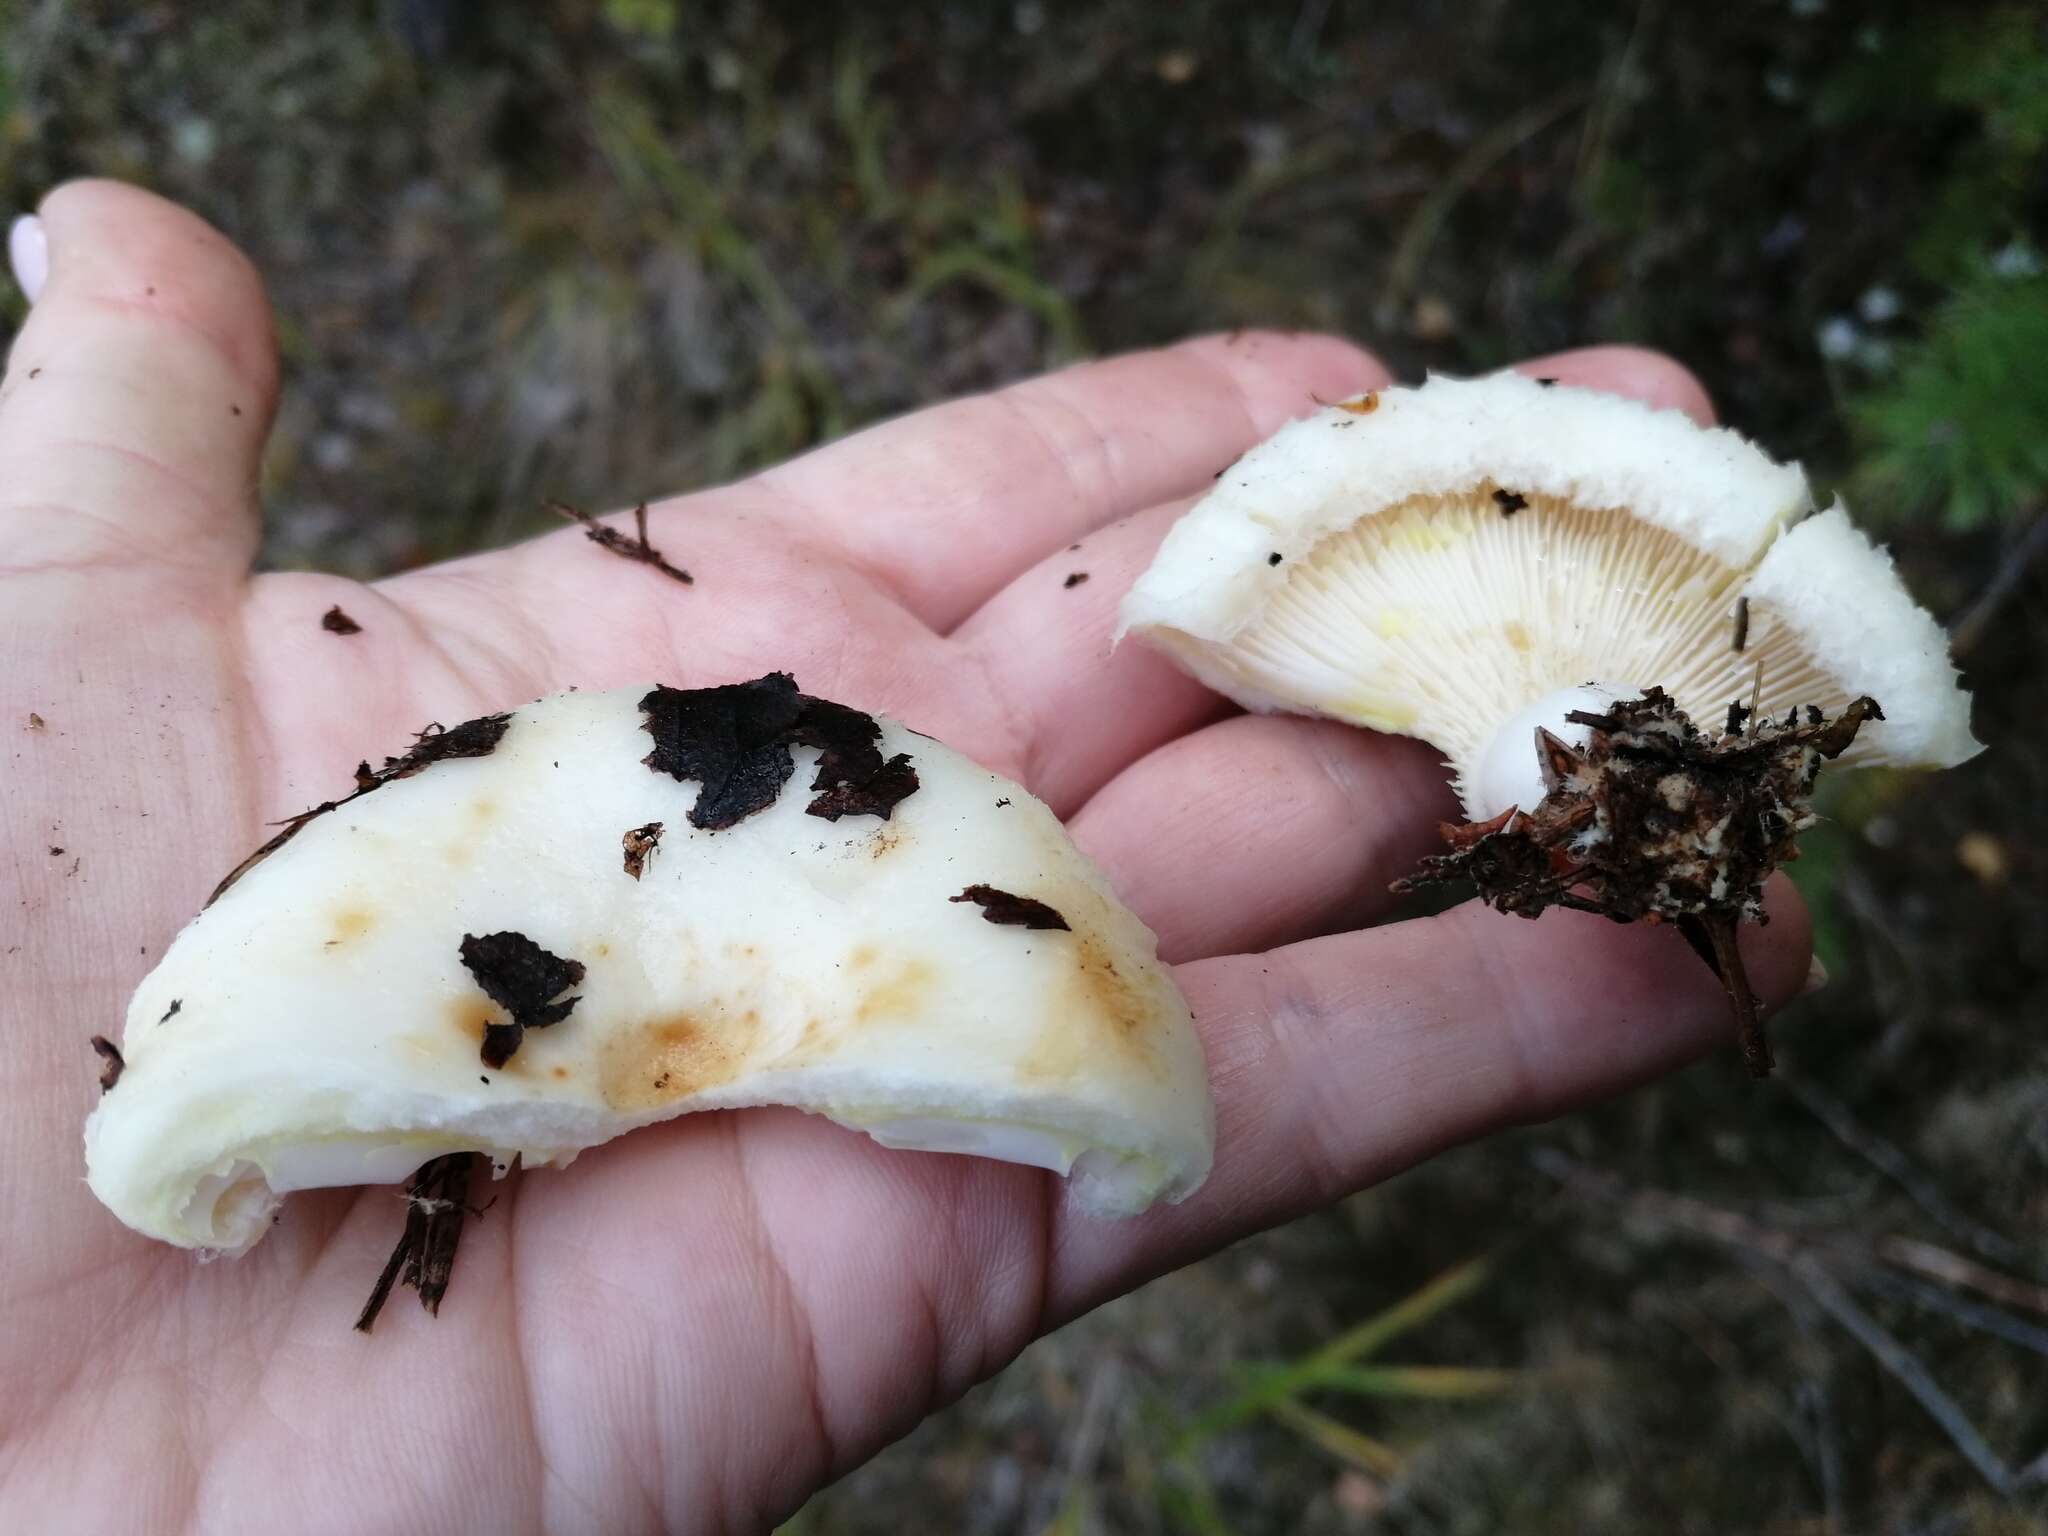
left=0, top=182, right=276, bottom=573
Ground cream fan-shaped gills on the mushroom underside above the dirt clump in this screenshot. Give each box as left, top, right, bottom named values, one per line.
left=1212, top=483, right=1853, bottom=815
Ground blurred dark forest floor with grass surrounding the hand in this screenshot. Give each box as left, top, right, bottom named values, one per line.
left=0, top=0, right=2048, bottom=1536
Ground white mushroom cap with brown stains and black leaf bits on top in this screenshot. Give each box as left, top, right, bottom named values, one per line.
left=86, top=688, right=1214, bottom=1251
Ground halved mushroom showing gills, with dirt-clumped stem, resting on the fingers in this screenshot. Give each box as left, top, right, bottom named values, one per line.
left=1122, top=373, right=1980, bottom=1073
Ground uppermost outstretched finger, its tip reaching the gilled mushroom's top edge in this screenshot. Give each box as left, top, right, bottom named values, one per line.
left=758, top=332, right=1386, bottom=631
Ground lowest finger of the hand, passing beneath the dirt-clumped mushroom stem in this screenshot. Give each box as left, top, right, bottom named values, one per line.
left=1047, top=877, right=1810, bottom=1327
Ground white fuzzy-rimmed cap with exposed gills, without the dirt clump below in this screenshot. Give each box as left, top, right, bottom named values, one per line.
left=1122, top=373, right=1978, bottom=817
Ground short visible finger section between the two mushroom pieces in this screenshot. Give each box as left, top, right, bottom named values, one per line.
left=1069, top=715, right=1458, bottom=963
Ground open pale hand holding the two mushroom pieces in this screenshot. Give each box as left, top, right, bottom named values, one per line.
left=0, top=182, right=1808, bottom=1532
